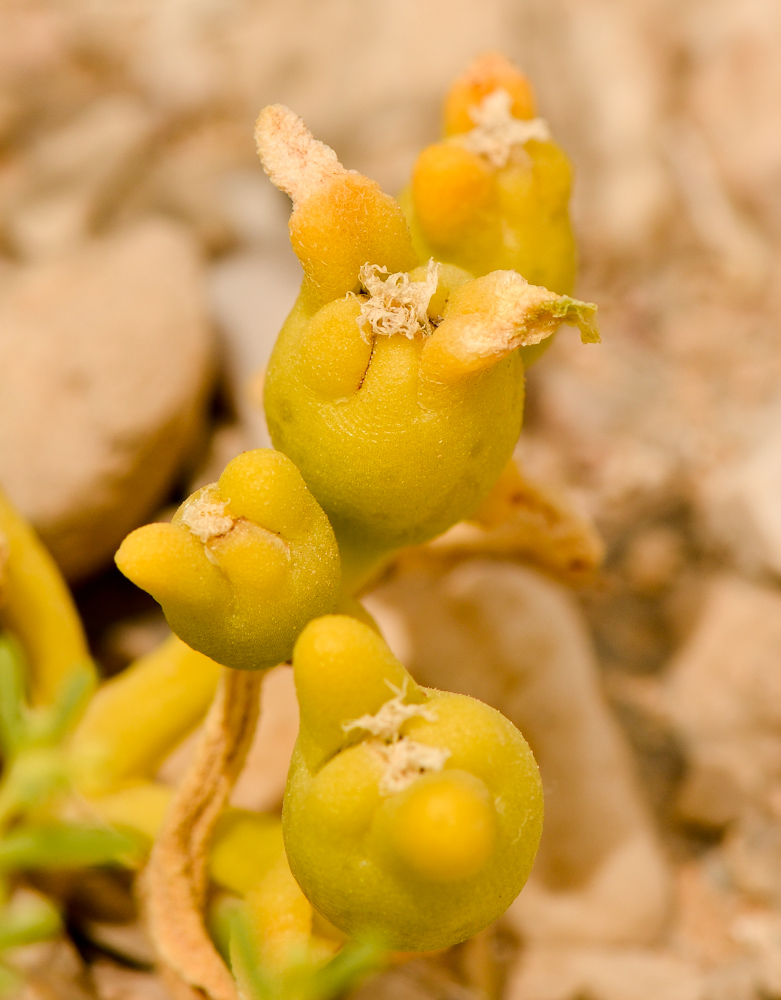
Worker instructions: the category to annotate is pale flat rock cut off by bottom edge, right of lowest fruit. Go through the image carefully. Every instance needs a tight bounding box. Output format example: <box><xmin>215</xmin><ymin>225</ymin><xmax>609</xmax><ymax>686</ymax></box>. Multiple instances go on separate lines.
<box><xmin>504</xmin><ymin>947</ymin><xmax>706</xmax><ymax>1000</ymax></box>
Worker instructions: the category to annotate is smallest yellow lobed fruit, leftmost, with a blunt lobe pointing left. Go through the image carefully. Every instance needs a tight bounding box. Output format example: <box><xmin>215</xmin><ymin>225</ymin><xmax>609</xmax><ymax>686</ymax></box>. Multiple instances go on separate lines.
<box><xmin>116</xmin><ymin>448</ymin><xmax>340</xmax><ymax>670</ymax></box>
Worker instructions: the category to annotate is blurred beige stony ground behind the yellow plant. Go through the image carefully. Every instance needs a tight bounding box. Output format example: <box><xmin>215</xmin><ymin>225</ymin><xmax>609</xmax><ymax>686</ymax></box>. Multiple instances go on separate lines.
<box><xmin>0</xmin><ymin>0</ymin><xmax>781</xmax><ymax>1000</ymax></box>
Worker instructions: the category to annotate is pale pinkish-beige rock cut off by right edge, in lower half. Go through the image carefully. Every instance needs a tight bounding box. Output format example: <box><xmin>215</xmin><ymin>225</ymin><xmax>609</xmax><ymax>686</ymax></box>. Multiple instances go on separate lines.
<box><xmin>665</xmin><ymin>576</ymin><xmax>781</xmax><ymax>825</ymax></box>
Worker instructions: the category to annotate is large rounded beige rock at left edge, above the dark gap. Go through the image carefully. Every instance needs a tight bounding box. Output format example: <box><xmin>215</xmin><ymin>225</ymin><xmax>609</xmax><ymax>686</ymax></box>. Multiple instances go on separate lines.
<box><xmin>0</xmin><ymin>220</ymin><xmax>213</xmax><ymax>578</ymax></box>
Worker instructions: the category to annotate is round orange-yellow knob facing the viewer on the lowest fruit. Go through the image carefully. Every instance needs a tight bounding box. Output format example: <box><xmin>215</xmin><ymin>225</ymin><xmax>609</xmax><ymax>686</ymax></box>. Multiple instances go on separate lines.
<box><xmin>389</xmin><ymin>771</ymin><xmax>496</xmax><ymax>882</ymax></box>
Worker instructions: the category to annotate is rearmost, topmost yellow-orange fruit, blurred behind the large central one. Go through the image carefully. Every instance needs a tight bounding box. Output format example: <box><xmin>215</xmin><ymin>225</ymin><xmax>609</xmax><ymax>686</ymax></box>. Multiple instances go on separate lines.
<box><xmin>401</xmin><ymin>53</ymin><xmax>576</xmax><ymax>365</ymax></box>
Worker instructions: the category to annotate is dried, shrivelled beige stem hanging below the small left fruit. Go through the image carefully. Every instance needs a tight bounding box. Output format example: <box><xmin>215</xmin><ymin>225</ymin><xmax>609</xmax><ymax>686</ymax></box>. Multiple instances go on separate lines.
<box><xmin>146</xmin><ymin>668</ymin><xmax>263</xmax><ymax>1000</ymax></box>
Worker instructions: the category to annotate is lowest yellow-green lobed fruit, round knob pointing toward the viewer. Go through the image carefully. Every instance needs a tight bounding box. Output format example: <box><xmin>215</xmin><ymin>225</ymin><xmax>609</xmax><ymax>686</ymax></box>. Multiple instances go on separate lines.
<box><xmin>283</xmin><ymin>615</ymin><xmax>543</xmax><ymax>951</ymax></box>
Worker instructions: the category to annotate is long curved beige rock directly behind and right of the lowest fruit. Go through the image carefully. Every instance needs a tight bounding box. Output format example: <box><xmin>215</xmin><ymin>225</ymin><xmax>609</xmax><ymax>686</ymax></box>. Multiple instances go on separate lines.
<box><xmin>364</xmin><ymin>561</ymin><xmax>670</xmax><ymax>943</ymax></box>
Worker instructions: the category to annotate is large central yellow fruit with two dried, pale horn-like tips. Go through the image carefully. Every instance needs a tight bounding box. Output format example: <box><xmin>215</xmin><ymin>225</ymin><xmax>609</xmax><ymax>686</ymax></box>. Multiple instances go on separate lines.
<box><xmin>257</xmin><ymin>106</ymin><xmax>593</xmax><ymax>590</ymax></box>
